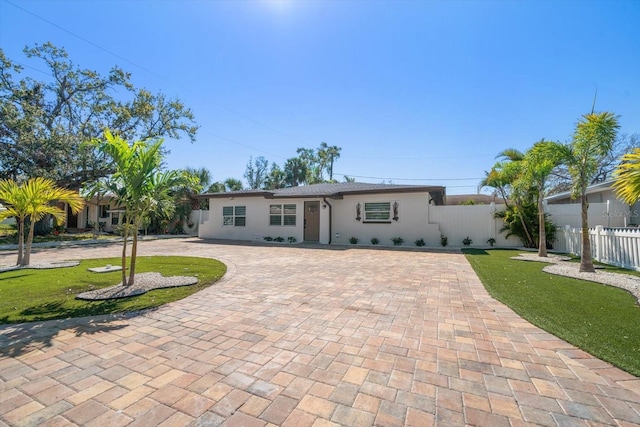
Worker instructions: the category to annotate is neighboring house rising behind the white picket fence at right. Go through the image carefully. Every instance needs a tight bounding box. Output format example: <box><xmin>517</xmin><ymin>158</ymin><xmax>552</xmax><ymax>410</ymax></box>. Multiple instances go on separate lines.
<box><xmin>544</xmin><ymin>181</ymin><xmax>640</xmax><ymax>227</ymax></box>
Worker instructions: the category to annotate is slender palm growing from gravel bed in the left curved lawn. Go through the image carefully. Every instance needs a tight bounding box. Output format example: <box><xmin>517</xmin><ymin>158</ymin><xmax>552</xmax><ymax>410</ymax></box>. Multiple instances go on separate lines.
<box><xmin>94</xmin><ymin>131</ymin><xmax>185</xmax><ymax>286</ymax></box>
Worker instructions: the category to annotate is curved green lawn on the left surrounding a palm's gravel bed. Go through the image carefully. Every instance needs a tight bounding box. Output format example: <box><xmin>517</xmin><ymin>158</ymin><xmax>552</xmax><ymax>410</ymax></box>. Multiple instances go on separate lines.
<box><xmin>0</xmin><ymin>256</ymin><xmax>227</xmax><ymax>324</ymax></box>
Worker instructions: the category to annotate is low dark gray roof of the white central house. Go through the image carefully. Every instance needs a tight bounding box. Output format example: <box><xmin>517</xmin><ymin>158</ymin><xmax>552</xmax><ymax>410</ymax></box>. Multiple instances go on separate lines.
<box><xmin>200</xmin><ymin>182</ymin><xmax>445</xmax><ymax>204</ymax></box>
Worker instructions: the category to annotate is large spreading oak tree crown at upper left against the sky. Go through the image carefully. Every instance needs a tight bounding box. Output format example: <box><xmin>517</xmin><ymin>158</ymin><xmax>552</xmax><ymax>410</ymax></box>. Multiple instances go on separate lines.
<box><xmin>0</xmin><ymin>43</ymin><xmax>198</xmax><ymax>189</ymax></box>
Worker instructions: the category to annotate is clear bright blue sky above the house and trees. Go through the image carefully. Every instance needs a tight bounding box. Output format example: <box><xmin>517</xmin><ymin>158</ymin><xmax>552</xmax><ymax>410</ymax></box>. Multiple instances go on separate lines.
<box><xmin>0</xmin><ymin>0</ymin><xmax>640</xmax><ymax>194</ymax></box>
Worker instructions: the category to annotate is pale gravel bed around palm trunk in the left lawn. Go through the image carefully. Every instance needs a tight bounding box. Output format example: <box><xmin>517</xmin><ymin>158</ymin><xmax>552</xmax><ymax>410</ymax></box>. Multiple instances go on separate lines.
<box><xmin>76</xmin><ymin>273</ymin><xmax>198</xmax><ymax>301</ymax></box>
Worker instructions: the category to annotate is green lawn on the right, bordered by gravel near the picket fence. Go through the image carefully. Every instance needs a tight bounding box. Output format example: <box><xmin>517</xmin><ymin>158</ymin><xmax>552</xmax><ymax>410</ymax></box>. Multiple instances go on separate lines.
<box><xmin>464</xmin><ymin>249</ymin><xmax>640</xmax><ymax>376</ymax></box>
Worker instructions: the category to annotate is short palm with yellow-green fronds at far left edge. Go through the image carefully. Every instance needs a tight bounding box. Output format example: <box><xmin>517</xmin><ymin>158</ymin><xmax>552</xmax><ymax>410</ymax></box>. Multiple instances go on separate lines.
<box><xmin>0</xmin><ymin>178</ymin><xmax>84</xmax><ymax>265</ymax></box>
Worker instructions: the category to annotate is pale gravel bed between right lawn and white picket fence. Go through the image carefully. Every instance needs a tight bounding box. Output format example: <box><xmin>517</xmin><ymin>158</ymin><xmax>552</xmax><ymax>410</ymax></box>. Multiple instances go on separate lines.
<box><xmin>513</xmin><ymin>253</ymin><xmax>640</xmax><ymax>303</ymax></box>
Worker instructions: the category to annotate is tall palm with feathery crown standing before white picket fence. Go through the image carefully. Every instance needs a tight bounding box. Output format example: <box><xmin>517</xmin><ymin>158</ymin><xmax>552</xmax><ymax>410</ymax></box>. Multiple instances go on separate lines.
<box><xmin>555</xmin><ymin>112</ymin><xmax>620</xmax><ymax>273</ymax></box>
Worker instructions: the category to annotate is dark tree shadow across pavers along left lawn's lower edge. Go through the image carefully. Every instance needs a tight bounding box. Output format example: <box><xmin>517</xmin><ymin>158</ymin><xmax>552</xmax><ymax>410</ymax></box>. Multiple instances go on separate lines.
<box><xmin>0</xmin><ymin>302</ymin><xmax>158</xmax><ymax>357</ymax></box>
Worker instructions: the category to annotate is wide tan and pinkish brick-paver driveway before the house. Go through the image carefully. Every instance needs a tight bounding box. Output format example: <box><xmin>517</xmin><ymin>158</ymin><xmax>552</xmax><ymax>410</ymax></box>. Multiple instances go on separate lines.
<box><xmin>0</xmin><ymin>239</ymin><xmax>640</xmax><ymax>426</ymax></box>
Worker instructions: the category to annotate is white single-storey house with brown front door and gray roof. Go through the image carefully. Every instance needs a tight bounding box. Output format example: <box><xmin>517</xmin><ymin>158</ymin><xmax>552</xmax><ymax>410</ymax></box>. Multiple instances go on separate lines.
<box><xmin>198</xmin><ymin>182</ymin><xmax>445</xmax><ymax>245</ymax></box>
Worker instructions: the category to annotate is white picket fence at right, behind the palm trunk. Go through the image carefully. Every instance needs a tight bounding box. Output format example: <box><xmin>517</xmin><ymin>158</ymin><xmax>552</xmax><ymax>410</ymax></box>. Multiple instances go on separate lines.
<box><xmin>554</xmin><ymin>225</ymin><xmax>640</xmax><ymax>271</ymax></box>
